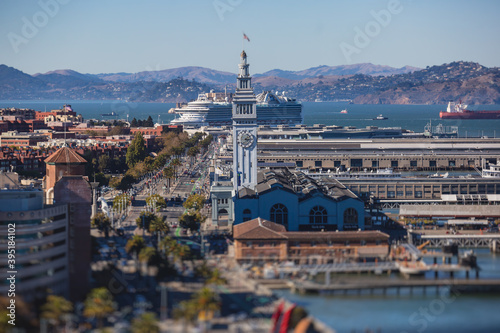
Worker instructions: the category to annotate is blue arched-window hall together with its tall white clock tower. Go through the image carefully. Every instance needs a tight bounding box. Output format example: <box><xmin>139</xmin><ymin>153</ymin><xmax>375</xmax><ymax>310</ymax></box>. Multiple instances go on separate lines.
<box><xmin>212</xmin><ymin>51</ymin><xmax>365</xmax><ymax>231</ymax></box>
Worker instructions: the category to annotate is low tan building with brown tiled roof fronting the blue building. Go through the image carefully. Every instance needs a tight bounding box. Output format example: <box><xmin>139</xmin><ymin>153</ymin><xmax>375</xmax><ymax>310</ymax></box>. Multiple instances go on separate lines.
<box><xmin>233</xmin><ymin>218</ymin><xmax>389</xmax><ymax>264</ymax></box>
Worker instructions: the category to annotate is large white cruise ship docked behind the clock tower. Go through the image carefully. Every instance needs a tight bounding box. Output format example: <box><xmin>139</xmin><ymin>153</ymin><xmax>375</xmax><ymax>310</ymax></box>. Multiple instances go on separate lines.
<box><xmin>171</xmin><ymin>91</ymin><xmax>302</xmax><ymax>127</ymax></box>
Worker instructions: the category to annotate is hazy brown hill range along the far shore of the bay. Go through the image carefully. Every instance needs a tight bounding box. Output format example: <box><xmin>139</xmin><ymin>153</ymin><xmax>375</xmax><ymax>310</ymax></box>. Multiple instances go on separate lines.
<box><xmin>0</xmin><ymin>61</ymin><xmax>500</xmax><ymax>104</ymax></box>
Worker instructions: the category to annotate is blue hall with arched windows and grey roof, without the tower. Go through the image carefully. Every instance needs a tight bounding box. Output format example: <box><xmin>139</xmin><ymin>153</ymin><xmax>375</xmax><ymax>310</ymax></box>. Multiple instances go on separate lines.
<box><xmin>234</xmin><ymin>170</ymin><xmax>365</xmax><ymax>231</ymax></box>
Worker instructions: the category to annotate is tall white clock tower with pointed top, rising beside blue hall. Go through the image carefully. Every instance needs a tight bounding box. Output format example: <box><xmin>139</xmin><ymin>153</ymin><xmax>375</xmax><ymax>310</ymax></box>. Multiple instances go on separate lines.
<box><xmin>233</xmin><ymin>51</ymin><xmax>257</xmax><ymax>191</ymax></box>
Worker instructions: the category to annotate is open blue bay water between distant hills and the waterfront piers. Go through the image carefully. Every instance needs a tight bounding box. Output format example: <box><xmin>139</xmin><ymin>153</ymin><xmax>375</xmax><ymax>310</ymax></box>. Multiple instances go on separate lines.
<box><xmin>0</xmin><ymin>100</ymin><xmax>500</xmax><ymax>137</ymax></box>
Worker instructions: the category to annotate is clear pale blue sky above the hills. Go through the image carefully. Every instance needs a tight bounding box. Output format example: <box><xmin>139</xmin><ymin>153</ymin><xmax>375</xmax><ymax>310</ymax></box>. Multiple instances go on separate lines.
<box><xmin>0</xmin><ymin>0</ymin><xmax>500</xmax><ymax>74</ymax></box>
